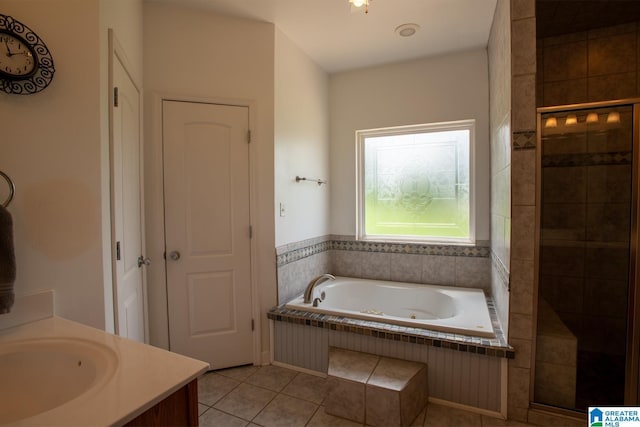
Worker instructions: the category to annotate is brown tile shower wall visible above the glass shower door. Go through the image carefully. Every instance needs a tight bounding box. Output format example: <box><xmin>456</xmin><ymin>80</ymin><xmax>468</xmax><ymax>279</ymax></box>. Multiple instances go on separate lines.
<box><xmin>536</xmin><ymin>22</ymin><xmax>640</xmax><ymax>107</ymax></box>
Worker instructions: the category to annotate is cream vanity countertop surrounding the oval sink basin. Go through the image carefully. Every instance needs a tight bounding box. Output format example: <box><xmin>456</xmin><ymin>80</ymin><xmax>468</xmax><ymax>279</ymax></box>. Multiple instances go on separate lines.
<box><xmin>0</xmin><ymin>317</ymin><xmax>209</xmax><ymax>426</ymax></box>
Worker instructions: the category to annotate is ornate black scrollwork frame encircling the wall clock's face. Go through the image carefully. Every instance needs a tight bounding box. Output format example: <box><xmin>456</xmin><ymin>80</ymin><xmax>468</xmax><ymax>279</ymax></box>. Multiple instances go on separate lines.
<box><xmin>0</xmin><ymin>14</ymin><xmax>55</xmax><ymax>95</ymax></box>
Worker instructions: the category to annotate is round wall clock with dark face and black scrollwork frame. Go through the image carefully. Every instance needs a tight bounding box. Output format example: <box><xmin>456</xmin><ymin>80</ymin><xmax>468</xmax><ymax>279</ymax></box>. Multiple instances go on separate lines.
<box><xmin>0</xmin><ymin>14</ymin><xmax>55</xmax><ymax>95</ymax></box>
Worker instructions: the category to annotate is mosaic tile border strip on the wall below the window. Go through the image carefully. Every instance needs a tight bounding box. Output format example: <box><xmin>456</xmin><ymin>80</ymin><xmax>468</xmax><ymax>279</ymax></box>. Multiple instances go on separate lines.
<box><xmin>276</xmin><ymin>239</ymin><xmax>491</xmax><ymax>267</ymax></box>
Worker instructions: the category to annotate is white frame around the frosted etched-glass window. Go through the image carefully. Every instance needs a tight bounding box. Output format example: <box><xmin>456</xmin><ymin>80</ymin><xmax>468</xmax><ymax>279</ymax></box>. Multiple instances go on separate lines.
<box><xmin>356</xmin><ymin>119</ymin><xmax>476</xmax><ymax>245</ymax></box>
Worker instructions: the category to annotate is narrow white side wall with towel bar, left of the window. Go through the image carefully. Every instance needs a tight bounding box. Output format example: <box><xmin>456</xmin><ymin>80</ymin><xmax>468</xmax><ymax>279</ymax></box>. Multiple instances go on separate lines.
<box><xmin>275</xmin><ymin>29</ymin><xmax>332</xmax><ymax>247</ymax></box>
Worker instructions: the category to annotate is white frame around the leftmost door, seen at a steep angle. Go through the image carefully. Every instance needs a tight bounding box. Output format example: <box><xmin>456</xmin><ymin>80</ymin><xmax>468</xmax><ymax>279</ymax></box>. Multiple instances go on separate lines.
<box><xmin>108</xmin><ymin>28</ymin><xmax>149</xmax><ymax>343</ymax></box>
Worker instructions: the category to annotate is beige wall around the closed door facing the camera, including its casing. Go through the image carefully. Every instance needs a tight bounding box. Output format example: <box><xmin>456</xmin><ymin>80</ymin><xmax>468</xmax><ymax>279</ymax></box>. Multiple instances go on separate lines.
<box><xmin>144</xmin><ymin>3</ymin><xmax>276</xmax><ymax>360</ymax></box>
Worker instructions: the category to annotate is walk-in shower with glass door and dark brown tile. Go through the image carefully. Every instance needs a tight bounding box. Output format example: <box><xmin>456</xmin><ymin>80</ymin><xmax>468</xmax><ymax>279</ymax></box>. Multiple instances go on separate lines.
<box><xmin>533</xmin><ymin>99</ymin><xmax>640</xmax><ymax>412</ymax></box>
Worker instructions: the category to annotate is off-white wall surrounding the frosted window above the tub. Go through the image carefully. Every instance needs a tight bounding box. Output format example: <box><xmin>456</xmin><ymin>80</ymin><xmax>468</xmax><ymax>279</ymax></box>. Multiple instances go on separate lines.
<box><xmin>329</xmin><ymin>49</ymin><xmax>490</xmax><ymax>241</ymax></box>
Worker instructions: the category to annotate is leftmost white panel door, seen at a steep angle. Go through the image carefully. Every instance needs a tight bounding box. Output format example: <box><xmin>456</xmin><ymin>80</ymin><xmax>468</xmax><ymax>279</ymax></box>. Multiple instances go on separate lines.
<box><xmin>111</xmin><ymin>55</ymin><xmax>146</xmax><ymax>342</ymax></box>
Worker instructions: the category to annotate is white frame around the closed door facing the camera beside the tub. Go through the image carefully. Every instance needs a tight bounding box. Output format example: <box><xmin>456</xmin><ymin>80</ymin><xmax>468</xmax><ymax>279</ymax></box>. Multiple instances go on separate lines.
<box><xmin>145</xmin><ymin>92</ymin><xmax>263</xmax><ymax>365</ymax></box>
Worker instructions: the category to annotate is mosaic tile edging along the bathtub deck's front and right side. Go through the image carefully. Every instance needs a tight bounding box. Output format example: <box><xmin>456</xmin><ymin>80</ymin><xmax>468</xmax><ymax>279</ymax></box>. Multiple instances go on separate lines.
<box><xmin>267</xmin><ymin>297</ymin><xmax>515</xmax><ymax>359</ymax></box>
